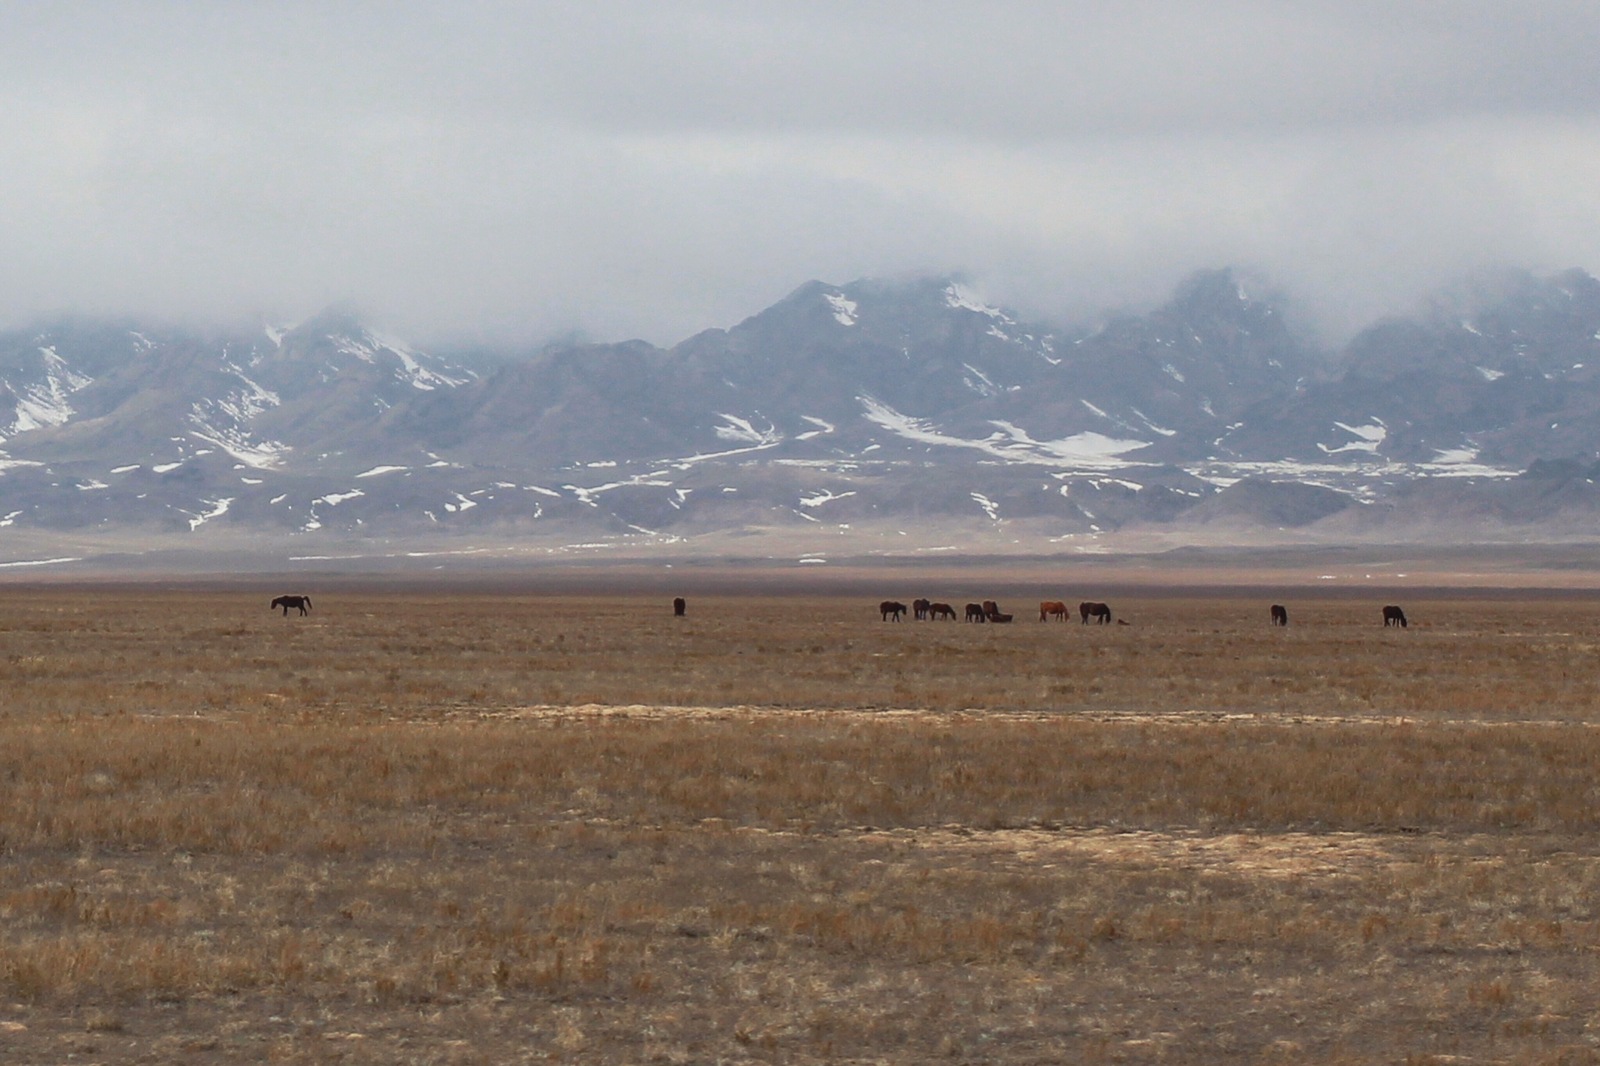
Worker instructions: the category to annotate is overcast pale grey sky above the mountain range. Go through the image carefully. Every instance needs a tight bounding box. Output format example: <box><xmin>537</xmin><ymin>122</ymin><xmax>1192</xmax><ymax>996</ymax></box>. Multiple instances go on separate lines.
<box><xmin>0</xmin><ymin>0</ymin><xmax>1600</xmax><ymax>344</ymax></box>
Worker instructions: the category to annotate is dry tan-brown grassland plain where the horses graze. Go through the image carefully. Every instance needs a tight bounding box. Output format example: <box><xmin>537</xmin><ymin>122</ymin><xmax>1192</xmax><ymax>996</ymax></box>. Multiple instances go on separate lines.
<box><xmin>0</xmin><ymin>579</ymin><xmax>1600</xmax><ymax>1064</ymax></box>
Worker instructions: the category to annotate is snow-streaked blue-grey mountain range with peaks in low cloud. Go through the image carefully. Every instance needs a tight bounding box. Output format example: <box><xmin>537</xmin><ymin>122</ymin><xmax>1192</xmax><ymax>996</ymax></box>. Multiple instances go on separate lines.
<box><xmin>0</xmin><ymin>271</ymin><xmax>1600</xmax><ymax>549</ymax></box>
